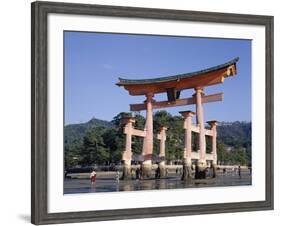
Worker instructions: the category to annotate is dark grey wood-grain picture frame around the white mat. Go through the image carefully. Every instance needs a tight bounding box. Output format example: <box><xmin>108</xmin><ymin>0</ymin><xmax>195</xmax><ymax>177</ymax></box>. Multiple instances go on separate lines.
<box><xmin>31</xmin><ymin>2</ymin><xmax>274</xmax><ymax>224</ymax></box>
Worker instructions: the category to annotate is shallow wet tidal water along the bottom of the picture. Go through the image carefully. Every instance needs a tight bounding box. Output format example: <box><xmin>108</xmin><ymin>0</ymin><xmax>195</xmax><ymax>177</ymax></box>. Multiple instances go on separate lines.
<box><xmin>64</xmin><ymin>172</ymin><xmax>252</xmax><ymax>194</ymax></box>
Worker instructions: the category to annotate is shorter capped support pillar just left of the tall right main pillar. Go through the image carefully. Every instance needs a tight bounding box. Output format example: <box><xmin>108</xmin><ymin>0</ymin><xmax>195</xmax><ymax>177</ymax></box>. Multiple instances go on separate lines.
<box><xmin>180</xmin><ymin>111</ymin><xmax>195</xmax><ymax>180</ymax></box>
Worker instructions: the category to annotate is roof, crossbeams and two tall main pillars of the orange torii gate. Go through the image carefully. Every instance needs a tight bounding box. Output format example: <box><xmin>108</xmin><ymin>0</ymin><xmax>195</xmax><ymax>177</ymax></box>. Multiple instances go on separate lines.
<box><xmin>116</xmin><ymin>58</ymin><xmax>239</xmax><ymax>178</ymax></box>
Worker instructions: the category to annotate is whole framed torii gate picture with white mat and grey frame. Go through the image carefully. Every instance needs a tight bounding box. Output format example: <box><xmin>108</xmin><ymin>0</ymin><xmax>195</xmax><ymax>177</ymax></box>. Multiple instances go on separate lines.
<box><xmin>31</xmin><ymin>2</ymin><xmax>273</xmax><ymax>224</ymax></box>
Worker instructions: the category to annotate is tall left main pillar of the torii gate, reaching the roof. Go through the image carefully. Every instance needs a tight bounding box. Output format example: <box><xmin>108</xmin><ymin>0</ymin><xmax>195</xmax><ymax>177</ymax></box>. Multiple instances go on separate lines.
<box><xmin>142</xmin><ymin>93</ymin><xmax>154</xmax><ymax>178</ymax></box>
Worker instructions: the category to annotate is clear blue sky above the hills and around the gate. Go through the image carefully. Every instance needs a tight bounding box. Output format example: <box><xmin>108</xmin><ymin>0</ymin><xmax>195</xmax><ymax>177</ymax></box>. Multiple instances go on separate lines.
<box><xmin>64</xmin><ymin>32</ymin><xmax>252</xmax><ymax>124</ymax></box>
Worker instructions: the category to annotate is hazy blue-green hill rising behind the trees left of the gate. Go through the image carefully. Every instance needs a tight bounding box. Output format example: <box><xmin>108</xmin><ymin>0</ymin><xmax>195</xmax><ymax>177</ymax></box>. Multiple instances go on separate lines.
<box><xmin>64</xmin><ymin>117</ymin><xmax>114</xmax><ymax>144</ymax></box>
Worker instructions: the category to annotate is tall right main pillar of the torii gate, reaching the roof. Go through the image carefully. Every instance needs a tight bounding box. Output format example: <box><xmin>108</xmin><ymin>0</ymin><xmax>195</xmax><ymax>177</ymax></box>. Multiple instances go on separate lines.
<box><xmin>195</xmin><ymin>87</ymin><xmax>206</xmax><ymax>179</ymax></box>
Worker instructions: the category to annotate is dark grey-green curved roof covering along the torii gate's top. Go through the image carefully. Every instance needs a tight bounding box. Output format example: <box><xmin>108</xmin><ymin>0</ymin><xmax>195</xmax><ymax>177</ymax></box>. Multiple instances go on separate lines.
<box><xmin>116</xmin><ymin>57</ymin><xmax>239</xmax><ymax>86</ymax></box>
